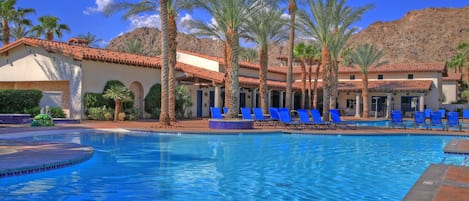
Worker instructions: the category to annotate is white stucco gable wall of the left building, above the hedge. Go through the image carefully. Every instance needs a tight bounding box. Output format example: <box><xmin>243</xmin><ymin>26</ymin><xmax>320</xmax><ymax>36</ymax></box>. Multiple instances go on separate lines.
<box><xmin>0</xmin><ymin>46</ymin><xmax>82</xmax><ymax>118</ymax></box>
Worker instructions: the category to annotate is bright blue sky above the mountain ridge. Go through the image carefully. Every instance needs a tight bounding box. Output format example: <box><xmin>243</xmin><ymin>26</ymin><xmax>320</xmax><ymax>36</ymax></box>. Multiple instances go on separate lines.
<box><xmin>12</xmin><ymin>0</ymin><xmax>469</xmax><ymax>46</ymax></box>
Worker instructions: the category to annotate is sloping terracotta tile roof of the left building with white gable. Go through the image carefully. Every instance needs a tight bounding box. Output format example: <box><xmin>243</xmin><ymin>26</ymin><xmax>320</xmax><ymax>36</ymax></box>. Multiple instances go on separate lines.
<box><xmin>0</xmin><ymin>38</ymin><xmax>160</xmax><ymax>68</ymax></box>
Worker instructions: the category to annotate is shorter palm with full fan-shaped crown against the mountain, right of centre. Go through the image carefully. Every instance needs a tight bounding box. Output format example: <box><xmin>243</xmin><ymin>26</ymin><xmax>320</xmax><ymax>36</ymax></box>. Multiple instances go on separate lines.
<box><xmin>344</xmin><ymin>44</ymin><xmax>384</xmax><ymax>118</ymax></box>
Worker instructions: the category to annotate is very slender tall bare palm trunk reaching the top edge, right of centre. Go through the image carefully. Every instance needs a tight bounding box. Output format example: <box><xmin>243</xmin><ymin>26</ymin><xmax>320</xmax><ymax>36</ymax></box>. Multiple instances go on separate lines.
<box><xmin>285</xmin><ymin>0</ymin><xmax>297</xmax><ymax>109</ymax></box>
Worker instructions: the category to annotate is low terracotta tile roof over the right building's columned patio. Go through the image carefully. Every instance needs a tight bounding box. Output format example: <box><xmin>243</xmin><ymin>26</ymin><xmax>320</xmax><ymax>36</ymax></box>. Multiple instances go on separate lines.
<box><xmin>294</xmin><ymin>80</ymin><xmax>433</xmax><ymax>92</ymax></box>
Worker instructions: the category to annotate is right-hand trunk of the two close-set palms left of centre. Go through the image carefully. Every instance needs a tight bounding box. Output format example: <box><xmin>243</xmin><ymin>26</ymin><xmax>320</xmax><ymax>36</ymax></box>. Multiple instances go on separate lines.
<box><xmin>168</xmin><ymin>10</ymin><xmax>177</xmax><ymax>122</ymax></box>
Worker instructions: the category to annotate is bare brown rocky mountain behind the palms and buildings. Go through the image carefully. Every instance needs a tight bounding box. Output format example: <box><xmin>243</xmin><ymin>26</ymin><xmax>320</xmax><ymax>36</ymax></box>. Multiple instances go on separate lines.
<box><xmin>107</xmin><ymin>6</ymin><xmax>469</xmax><ymax>66</ymax></box>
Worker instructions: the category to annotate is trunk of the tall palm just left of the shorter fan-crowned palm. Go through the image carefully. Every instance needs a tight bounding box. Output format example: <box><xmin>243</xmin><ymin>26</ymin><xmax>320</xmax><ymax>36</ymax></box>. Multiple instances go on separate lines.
<box><xmin>321</xmin><ymin>46</ymin><xmax>331</xmax><ymax>121</ymax></box>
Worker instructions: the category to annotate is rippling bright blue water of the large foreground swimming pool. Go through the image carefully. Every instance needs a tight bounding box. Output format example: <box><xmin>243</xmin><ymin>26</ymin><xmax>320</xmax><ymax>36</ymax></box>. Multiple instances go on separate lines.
<box><xmin>0</xmin><ymin>133</ymin><xmax>462</xmax><ymax>201</ymax></box>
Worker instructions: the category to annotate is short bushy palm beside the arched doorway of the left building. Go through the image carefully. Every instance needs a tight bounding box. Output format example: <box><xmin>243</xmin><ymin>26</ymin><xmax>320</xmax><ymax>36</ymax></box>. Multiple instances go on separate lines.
<box><xmin>103</xmin><ymin>85</ymin><xmax>132</xmax><ymax>121</ymax></box>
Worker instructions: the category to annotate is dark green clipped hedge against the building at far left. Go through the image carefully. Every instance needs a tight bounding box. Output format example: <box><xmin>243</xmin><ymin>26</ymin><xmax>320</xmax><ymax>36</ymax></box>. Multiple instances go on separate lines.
<box><xmin>0</xmin><ymin>89</ymin><xmax>42</xmax><ymax>114</ymax></box>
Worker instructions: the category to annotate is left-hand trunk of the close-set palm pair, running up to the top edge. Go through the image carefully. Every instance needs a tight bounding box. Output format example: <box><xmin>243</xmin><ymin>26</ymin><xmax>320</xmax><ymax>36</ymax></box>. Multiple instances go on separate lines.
<box><xmin>160</xmin><ymin>0</ymin><xmax>170</xmax><ymax>126</ymax></box>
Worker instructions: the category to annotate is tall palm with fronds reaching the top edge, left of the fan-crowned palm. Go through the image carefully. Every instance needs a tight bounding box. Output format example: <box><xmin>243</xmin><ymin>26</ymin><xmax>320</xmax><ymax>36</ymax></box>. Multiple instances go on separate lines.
<box><xmin>300</xmin><ymin>0</ymin><xmax>371</xmax><ymax>119</ymax></box>
